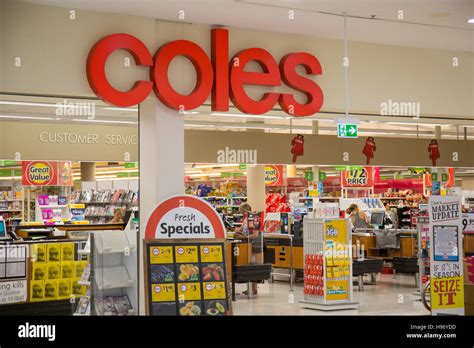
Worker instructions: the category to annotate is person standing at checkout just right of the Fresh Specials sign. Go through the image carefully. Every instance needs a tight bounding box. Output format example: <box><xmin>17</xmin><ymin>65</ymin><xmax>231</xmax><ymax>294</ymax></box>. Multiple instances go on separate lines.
<box><xmin>235</xmin><ymin>203</ymin><xmax>263</xmax><ymax>295</ymax></box>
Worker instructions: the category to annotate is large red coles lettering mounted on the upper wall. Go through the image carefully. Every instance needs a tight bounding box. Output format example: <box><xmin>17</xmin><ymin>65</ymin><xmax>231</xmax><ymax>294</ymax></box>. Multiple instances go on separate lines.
<box><xmin>87</xmin><ymin>29</ymin><xmax>323</xmax><ymax>116</ymax></box>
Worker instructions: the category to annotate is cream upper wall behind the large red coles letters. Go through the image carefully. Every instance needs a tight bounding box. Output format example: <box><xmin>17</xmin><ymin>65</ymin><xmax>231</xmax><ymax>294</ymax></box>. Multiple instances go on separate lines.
<box><xmin>0</xmin><ymin>1</ymin><xmax>474</xmax><ymax>116</ymax></box>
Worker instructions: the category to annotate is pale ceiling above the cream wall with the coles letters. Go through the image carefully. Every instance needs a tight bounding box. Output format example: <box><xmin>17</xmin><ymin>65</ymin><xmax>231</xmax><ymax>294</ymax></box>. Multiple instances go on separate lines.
<box><xmin>25</xmin><ymin>0</ymin><xmax>474</xmax><ymax>52</ymax></box>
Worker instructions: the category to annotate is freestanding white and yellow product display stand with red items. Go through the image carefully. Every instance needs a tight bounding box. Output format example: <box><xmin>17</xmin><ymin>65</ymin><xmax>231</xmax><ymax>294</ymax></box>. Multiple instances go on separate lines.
<box><xmin>300</xmin><ymin>218</ymin><xmax>359</xmax><ymax>311</ymax></box>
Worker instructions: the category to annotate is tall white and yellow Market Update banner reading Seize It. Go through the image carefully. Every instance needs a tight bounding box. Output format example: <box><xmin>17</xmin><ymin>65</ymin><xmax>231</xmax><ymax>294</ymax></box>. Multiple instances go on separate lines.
<box><xmin>429</xmin><ymin>196</ymin><xmax>464</xmax><ymax>315</ymax></box>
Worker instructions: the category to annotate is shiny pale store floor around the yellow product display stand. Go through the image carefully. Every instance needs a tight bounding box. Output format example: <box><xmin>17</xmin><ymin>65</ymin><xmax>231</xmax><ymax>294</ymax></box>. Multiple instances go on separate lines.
<box><xmin>233</xmin><ymin>274</ymin><xmax>429</xmax><ymax>315</ymax></box>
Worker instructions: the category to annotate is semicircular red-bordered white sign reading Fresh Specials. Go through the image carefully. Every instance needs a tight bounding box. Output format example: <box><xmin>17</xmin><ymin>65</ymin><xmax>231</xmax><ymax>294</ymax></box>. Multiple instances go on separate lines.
<box><xmin>145</xmin><ymin>195</ymin><xmax>226</xmax><ymax>240</ymax></box>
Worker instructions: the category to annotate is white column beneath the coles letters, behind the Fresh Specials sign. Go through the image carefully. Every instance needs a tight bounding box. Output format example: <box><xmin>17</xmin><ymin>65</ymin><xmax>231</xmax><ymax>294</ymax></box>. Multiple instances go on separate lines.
<box><xmin>139</xmin><ymin>95</ymin><xmax>184</xmax><ymax>314</ymax></box>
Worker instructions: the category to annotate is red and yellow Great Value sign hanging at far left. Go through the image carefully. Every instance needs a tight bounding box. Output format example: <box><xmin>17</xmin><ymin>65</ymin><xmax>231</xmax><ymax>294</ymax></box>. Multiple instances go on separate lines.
<box><xmin>21</xmin><ymin>161</ymin><xmax>74</xmax><ymax>186</ymax></box>
